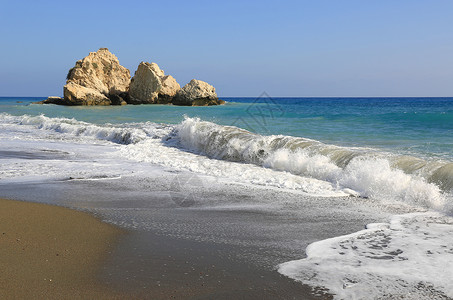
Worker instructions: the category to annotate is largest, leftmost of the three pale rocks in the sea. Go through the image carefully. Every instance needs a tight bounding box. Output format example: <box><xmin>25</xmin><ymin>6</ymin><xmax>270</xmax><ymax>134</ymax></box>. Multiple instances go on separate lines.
<box><xmin>61</xmin><ymin>48</ymin><xmax>130</xmax><ymax>105</ymax></box>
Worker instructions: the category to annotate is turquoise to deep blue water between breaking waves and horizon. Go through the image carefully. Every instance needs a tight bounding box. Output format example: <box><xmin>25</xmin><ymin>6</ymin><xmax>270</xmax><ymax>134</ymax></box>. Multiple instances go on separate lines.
<box><xmin>0</xmin><ymin>95</ymin><xmax>453</xmax><ymax>160</ymax></box>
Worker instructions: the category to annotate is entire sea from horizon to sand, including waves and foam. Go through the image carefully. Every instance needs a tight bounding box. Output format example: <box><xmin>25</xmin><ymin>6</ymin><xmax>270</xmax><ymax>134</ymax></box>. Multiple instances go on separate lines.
<box><xmin>0</xmin><ymin>93</ymin><xmax>453</xmax><ymax>299</ymax></box>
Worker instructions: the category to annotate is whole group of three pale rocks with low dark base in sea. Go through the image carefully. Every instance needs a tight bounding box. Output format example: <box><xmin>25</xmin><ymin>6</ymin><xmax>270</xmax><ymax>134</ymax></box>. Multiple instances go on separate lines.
<box><xmin>38</xmin><ymin>48</ymin><xmax>225</xmax><ymax>106</ymax></box>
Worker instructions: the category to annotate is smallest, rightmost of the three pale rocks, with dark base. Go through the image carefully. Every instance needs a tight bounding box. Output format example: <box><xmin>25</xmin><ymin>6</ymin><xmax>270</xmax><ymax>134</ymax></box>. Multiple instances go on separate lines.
<box><xmin>173</xmin><ymin>79</ymin><xmax>225</xmax><ymax>106</ymax></box>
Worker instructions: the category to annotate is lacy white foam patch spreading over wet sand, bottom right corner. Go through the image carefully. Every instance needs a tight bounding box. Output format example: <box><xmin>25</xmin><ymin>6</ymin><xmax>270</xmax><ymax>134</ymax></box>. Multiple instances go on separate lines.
<box><xmin>278</xmin><ymin>213</ymin><xmax>453</xmax><ymax>299</ymax></box>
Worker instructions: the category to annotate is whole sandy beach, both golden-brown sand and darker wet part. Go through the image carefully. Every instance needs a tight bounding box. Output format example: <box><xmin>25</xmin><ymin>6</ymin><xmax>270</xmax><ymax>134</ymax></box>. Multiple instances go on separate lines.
<box><xmin>0</xmin><ymin>200</ymin><xmax>329</xmax><ymax>299</ymax></box>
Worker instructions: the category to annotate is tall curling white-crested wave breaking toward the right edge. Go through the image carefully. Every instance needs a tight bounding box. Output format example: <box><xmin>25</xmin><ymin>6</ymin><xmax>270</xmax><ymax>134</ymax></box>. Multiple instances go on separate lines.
<box><xmin>176</xmin><ymin>118</ymin><xmax>453</xmax><ymax>210</ymax></box>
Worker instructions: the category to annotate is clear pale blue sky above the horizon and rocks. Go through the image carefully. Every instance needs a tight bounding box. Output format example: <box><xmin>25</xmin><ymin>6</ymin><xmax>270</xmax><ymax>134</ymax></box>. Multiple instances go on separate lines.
<box><xmin>0</xmin><ymin>0</ymin><xmax>453</xmax><ymax>97</ymax></box>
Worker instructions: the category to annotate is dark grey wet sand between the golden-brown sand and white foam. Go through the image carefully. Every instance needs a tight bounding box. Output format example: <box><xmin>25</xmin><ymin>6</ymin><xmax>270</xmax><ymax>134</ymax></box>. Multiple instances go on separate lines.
<box><xmin>103</xmin><ymin>231</ymin><xmax>331</xmax><ymax>299</ymax></box>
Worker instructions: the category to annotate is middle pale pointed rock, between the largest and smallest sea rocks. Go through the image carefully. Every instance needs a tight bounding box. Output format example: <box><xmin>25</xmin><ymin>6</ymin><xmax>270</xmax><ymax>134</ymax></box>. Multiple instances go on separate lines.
<box><xmin>129</xmin><ymin>62</ymin><xmax>181</xmax><ymax>104</ymax></box>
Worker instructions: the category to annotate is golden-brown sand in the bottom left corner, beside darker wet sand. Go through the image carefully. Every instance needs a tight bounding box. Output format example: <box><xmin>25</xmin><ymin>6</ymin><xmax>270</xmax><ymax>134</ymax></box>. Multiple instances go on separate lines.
<box><xmin>0</xmin><ymin>199</ymin><xmax>124</xmax><ymax>299</ymax></box>
